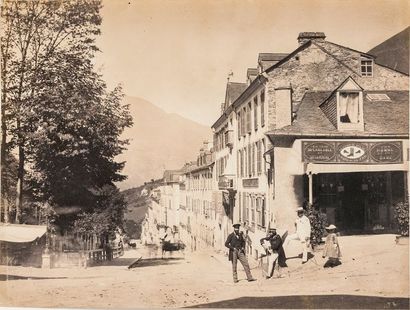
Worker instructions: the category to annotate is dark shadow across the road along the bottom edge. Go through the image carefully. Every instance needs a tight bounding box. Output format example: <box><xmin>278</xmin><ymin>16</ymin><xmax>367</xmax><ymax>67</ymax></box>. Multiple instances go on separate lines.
<box><xmin>189</xmin><ymin>295</ymin><xmax>409</xmax><ymax>309</ymax></box>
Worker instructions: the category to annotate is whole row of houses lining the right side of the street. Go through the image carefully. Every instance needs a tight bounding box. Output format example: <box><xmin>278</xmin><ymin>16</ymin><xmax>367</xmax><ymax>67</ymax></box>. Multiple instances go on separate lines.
<box><xmin>143</xmin><ymin>29</ymin><xmax>409</xmax><ymax>257</ymax></box>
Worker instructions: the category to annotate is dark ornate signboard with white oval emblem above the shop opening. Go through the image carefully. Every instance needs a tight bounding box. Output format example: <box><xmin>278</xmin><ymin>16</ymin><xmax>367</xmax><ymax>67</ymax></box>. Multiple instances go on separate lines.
<box><xmin>302</xmin><ymin>141</ymin><xmax>403</xmax><ymax>164</ymax></box>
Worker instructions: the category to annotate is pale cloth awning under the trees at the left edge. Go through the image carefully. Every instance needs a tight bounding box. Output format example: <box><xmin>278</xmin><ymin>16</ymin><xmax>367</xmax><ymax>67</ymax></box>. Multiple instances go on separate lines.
<box><xmin>0</xmin><ymin>224</ymin><xmax>47</xmax><ymax>242</ymax></box>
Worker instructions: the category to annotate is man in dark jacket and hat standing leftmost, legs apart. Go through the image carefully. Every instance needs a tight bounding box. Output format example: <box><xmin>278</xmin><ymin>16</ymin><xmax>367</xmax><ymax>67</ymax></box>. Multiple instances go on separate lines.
<box><xmin>225</xmin><ymin>224</ymin><xmax>256</xmax><ymax>283</ymax></box>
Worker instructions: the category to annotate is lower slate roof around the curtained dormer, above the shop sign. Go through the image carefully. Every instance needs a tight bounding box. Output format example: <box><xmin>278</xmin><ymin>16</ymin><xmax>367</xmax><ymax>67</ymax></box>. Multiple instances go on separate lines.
<box><xmin>267</xmin><ymin>91</ymin><xmax>409</xmax><ymax>137</ymax></box>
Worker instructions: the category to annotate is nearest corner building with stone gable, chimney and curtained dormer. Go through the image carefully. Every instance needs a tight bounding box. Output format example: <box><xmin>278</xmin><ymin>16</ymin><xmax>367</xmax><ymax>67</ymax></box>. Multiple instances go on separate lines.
<box><xmin>213</xmin><ymin>32</ymin><xmax>409</xmax><ymax>257</ymax></box>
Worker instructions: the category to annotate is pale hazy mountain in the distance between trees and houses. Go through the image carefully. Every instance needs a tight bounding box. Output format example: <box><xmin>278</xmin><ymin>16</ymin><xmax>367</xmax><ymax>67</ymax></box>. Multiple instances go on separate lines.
<box><xmin>118</xmin><ymin>96</ymin><xmax>211</xmax><ymax>189</ymax></box>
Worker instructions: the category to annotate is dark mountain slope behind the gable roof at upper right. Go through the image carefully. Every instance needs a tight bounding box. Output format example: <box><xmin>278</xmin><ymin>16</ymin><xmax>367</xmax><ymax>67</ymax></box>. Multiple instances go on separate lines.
<box><xmin>368</xmin><ymin>27</ymin><xmax>410</xmax><ymax>74</ymax></box>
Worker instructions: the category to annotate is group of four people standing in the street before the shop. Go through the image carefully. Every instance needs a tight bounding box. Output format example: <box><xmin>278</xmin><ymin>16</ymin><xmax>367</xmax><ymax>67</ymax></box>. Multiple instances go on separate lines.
<box><xmin>225</xmin><ymin>208</ymin><xmax>341</xmax><ymax>283</ymax></box>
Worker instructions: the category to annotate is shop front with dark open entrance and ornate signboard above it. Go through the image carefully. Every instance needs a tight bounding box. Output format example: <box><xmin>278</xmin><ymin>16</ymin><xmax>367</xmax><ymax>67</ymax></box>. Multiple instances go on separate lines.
<box><xmin>302</xmin><ymin>140</ymin><xmax>408</xmax><ymax>233</ymax></box>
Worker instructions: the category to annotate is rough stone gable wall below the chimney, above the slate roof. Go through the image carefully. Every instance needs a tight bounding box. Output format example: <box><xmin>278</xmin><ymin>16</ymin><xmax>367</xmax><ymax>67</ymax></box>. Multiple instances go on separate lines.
<box><xmin>266</xmin><ymin>42</ymin><xmax>409</xmax><ymax>130</ymax></box>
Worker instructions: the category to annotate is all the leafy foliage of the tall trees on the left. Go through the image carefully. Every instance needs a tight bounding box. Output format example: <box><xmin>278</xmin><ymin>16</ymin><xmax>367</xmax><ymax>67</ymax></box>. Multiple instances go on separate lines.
<box><xmin>1</xmin><ymin>0</ymin><xmax>132</xmax><ymax>235</ymax></box>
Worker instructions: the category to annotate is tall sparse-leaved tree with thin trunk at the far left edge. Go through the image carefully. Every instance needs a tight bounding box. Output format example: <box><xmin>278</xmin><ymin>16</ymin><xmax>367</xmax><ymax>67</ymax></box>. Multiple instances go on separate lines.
<box><xmin>1</xmin><ymin>0</ymin><xmax>105</xmax><ymax>222</ymax></box>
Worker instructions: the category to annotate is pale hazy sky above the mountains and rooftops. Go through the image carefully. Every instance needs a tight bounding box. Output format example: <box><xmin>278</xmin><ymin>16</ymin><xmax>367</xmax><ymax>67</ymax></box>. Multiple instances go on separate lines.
<box><xmin>97</xmin><ymin>0</ymin><xmax>410</xmax><ymax>125</ymax></box>
